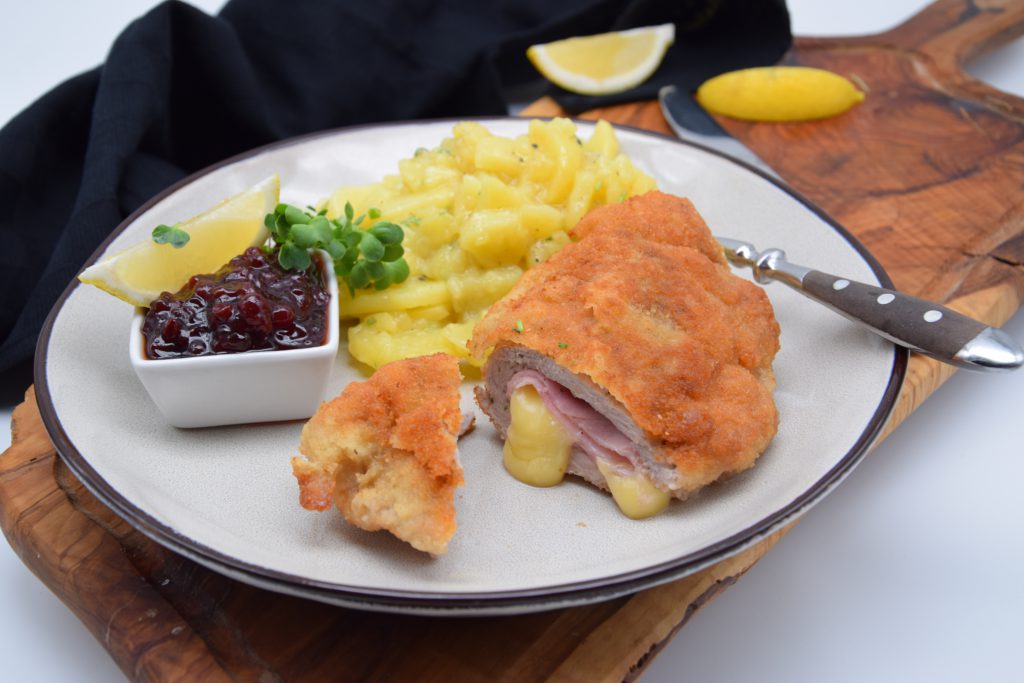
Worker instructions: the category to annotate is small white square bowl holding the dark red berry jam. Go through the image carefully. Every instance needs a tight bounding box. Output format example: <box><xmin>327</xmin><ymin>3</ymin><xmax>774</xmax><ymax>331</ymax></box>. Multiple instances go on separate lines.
<box><xmin>128</xmin><ymin>251</ymin><xmax>341</xmax><ymax>427</ymax></box>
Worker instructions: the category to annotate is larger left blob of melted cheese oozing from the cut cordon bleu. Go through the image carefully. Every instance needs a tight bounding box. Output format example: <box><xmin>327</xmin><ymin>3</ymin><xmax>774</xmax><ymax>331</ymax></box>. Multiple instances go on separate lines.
<box><xmin>505</xmin><ymin>384</ymin><xmax>572</xmax><ymax>486</ymax></box>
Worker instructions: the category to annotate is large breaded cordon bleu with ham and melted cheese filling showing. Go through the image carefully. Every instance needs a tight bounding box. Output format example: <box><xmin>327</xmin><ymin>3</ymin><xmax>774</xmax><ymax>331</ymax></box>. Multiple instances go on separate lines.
<box><xmin>469</xmin><ymin>191</ymin><xmax>779</xmax><ymax>518</ymax></box>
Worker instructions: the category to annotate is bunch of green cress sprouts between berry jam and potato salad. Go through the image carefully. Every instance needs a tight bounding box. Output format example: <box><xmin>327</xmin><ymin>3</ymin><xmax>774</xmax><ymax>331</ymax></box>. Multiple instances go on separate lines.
<box><xmin>263</xmin><ymin>198</ymin><xmax>409</xmax><ymax>295</ymax></box>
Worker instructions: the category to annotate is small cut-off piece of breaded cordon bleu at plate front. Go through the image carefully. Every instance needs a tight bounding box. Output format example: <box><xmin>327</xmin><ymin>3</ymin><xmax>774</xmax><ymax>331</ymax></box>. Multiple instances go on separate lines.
<box><xmin>292</xmin><ymin>353</ymin><xmax>463</xmax><ymax>555</ymax></box>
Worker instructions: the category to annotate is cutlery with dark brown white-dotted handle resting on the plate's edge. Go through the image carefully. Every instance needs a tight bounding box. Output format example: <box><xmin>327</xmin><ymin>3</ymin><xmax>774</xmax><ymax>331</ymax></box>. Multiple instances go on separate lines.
<box><xmin>717</xmin><ymin>238</ymin><xmax>1024</xmax><ymax>371</ymax></box>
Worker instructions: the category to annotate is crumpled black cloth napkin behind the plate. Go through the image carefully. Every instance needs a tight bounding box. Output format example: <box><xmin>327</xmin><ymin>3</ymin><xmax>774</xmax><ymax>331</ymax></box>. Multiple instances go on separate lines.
<box><xmin>0</xmin><ymin>0</ymin><xmax>791</xmax><ymax>383</ymax></box>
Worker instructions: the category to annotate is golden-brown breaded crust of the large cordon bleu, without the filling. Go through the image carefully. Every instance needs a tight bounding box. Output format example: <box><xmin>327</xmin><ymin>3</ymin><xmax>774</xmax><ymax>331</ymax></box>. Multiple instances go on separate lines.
<box><xmin>470</xmin><ymin>193</ymin><xmax>778</xmax><ymax>494</ymax></box>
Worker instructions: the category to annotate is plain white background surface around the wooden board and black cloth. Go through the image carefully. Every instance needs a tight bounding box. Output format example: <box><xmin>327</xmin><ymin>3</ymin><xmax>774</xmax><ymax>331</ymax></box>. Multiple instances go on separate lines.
<box><xmin>0</xmin><ymin>0</ymin><xmax>1024</xmax><ymax>683</ymax></box>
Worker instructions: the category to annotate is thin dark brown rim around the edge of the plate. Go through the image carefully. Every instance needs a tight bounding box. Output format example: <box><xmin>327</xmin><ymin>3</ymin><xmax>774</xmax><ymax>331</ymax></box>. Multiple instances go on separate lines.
<box><xmin>34</xmin><ymin>117</ymin><xmax>909</xmax><ymax>615</ymax></box>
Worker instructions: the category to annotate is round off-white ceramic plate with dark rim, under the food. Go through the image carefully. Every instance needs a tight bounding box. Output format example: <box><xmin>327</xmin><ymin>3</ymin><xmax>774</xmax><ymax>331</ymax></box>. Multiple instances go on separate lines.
<box><xmin>36</xmin><ymin>119</ymin><xmax>906</xmax><ymax>613</ymax></box>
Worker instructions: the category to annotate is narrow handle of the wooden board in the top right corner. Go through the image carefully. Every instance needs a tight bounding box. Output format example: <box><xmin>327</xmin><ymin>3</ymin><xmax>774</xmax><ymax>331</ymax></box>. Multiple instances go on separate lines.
<box><xmin>878</xmin><ymin>0</ymin><xmax>1024</xmax><ymax>68</ymax></box>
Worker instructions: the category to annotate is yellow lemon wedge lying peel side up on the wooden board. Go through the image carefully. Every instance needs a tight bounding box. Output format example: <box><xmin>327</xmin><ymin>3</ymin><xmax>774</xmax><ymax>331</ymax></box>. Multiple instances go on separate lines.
<box><xmin>697</xmin><ymin>67</ymin><xmax>864</xmax><ymax>122</ymax></box>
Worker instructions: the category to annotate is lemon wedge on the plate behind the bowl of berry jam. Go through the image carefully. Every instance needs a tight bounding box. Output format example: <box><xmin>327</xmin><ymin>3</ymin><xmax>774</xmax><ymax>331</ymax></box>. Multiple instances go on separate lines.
<box><xmin>78</xmin><ymin>174</ymin><xmax>281</xmax><ymax>306</ymax></box>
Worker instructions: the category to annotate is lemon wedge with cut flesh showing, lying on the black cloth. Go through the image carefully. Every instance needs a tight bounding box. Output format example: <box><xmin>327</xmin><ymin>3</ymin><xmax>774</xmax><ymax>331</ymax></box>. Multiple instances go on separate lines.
<box><xmin>526</xmin><ymin>24</ymin><xmax>676</xmax><ymax>95</ymax></box>
